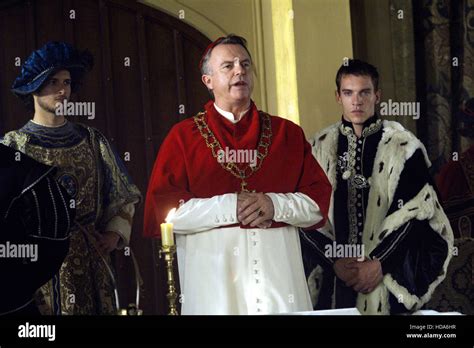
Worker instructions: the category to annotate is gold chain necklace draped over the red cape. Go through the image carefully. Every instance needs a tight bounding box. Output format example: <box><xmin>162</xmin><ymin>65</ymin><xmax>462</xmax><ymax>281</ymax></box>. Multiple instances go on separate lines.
<box><xmin>194</xmin><ymin>111</ymin><xmax>272</xmax><ymax>192</ymax></box>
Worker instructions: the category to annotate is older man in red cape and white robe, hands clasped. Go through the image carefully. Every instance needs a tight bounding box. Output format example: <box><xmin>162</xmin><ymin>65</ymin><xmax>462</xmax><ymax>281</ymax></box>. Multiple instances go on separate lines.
<box><xmin>144</xmin><ymin>34</ymin><xmax>331</xmax><ymax>314</ymax></box>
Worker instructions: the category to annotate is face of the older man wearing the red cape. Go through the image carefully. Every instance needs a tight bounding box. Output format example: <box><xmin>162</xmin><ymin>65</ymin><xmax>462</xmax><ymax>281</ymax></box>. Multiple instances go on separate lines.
<box><xmin>202</xmin><ymin>45</ymin><xmax>253</xmax><ymax>106</ymax></box>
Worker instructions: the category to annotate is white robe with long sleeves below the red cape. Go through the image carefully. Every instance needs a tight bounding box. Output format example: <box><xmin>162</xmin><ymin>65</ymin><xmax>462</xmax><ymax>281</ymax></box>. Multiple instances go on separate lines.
<box><xmin>171</xmin><ymin>193</ymin><xmax>322</xmax><ymax>315</ymax></box>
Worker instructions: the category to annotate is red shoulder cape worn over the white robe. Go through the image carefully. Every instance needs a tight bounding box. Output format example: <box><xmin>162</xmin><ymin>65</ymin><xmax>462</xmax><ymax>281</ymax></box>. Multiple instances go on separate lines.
<box><xmin>144</xmin><ymin>101</ymin><xmax>331</xmax><ymax>237</ymax></box>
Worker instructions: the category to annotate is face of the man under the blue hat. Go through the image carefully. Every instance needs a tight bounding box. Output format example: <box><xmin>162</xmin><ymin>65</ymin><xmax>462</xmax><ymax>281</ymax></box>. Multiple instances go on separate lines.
<box><xmin>33</xmin><ymin>70</ymin><xmax>71</xmax><ymax>113</ymax></box>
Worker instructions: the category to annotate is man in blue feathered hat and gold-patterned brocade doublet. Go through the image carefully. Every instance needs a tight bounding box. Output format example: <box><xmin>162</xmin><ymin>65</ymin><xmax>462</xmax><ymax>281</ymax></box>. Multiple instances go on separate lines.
<box><xmin>1</xmin><ymin>42</ymin><xmax>141</xmax><ymax>315</ymax></box>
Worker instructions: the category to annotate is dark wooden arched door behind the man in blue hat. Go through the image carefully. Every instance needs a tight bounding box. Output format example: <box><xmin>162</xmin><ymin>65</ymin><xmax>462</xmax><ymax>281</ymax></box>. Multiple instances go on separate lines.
<box><xmin>0</xmin><ymin>0</ymin><xmax>210</xmax><ymax>314</ymax></box>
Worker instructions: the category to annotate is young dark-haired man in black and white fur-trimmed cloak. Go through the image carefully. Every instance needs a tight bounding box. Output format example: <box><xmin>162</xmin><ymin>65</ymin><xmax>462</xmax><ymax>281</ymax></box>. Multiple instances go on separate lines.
<box><xmin>301</xmin><ymin>60</ymin><xmax>453</xmax><ymax>314</ymax></box>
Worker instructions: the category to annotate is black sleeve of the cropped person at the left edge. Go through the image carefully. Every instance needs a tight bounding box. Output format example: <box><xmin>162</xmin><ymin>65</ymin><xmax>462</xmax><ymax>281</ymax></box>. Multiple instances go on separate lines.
<box><xmin>0</xmin><ymin>175</ymin><xmax>75</xmax><ymax>313</ymax></box>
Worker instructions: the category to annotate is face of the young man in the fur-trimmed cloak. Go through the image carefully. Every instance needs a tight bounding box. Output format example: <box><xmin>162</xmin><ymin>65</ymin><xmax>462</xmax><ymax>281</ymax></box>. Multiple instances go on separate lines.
<box><xmin>336</xmin><ymin>75</ymin><xmax>380</xmax><ymax>125</ymax></box>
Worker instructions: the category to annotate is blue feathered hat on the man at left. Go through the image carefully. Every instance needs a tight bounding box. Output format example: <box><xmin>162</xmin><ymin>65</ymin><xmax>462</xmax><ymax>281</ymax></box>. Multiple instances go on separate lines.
<box><xmin>12</xmin><ymin>41</ymin><xmax>94</xmax><ymax>97</ymax></box>
